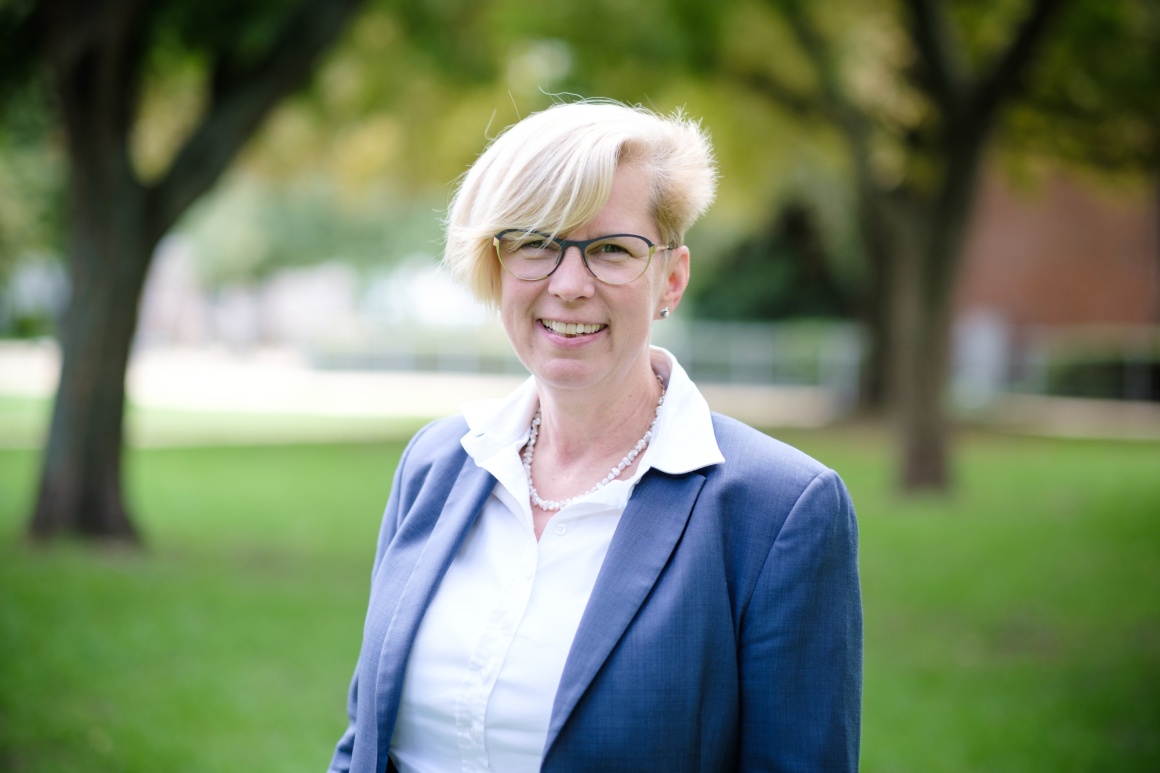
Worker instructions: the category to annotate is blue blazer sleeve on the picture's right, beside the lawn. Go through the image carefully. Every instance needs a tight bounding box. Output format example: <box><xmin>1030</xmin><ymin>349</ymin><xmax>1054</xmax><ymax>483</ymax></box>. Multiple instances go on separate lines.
<box><xmin>739</xmin><ymin>470</ymin><xmax>862</xmax><ymax>772</ymax></box>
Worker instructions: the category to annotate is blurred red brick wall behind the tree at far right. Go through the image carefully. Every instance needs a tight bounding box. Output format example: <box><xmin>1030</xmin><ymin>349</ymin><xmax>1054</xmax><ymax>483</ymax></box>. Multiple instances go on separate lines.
<box><xmin>956</xmin><ymin>168</ymin><xmax>1160</xmax><ymax>326</ymax></box>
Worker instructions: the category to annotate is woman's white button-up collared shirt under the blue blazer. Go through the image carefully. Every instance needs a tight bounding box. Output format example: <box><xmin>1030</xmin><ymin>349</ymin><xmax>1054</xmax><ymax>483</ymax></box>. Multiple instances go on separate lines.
<box><xmin>391</xmin><ymin>347</ymin><xmax>724</xmax><ymax>773</ymax></box>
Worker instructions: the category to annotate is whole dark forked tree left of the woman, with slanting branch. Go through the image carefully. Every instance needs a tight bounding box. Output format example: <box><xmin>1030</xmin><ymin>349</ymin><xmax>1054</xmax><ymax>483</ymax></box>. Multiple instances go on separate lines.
<box><xmin>0</xmin><ymin>0</ymin><xmax>362</xmax><ymax>542</ymax></box>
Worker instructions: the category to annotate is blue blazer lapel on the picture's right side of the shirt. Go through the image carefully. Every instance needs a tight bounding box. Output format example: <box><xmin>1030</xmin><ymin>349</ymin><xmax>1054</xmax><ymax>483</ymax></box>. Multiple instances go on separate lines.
<box><xmin>544</xmin><ymin>471</ymin><xmax>705</xmax><ymax>756</ymax></box>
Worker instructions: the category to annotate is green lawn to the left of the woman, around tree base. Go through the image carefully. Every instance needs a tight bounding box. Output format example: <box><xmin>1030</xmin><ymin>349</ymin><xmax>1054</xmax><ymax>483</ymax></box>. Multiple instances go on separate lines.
<box><xmin>0</xmin><ymin>442</ymin><xmax>401</xmax><ymax>773</ymax></box>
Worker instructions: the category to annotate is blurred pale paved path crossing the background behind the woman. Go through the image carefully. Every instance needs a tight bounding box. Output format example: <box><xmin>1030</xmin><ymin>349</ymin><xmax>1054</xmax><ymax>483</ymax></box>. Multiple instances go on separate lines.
<box><xmin>0</xmin><ymin>342</ymin><xmax>1160</xmax><ymax>446</ymax></box>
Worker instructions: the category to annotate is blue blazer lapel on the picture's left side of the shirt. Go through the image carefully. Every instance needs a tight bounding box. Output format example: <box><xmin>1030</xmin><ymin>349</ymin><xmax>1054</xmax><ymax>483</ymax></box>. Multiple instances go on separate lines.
<box><xmin>376</xmin><ymin>458</ymin><xmax>495</xmax><ymax>767</ymax></box>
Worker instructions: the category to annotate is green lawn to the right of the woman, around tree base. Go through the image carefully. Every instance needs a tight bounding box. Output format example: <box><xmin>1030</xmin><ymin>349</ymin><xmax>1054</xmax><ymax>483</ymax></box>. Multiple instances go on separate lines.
<box><xmin>790</xmin><ymin>433</ymin><xmax>1160</xmax><ymax>772</ymax></box>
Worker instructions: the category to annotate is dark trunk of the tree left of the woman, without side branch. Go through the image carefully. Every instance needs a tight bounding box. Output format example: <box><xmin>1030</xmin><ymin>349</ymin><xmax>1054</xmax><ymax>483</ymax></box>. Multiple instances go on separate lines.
<box><xmin>30</xmin><ymin>0</ymin><xmax>151</xmax><ymax>542</ymax></box>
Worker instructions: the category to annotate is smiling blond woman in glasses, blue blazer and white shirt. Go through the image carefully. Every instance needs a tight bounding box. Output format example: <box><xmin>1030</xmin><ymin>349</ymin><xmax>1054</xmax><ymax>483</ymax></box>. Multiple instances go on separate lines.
<box><xmin>331</xmin><ymin>102</ymin><xmax>862</xmax><ymax>773</ymax></box>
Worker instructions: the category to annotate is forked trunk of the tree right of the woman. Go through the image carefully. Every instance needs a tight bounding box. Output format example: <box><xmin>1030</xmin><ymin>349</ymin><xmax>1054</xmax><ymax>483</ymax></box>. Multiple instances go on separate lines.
<box><xmin>894</xmin><ymin>0</ymin><xmax>1065</xmax><ymax>491</ymax></box>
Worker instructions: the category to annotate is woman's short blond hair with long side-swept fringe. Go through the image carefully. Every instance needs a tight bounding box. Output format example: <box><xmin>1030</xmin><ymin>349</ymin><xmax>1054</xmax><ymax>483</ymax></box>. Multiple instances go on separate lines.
<box><xmin>443</xmin><ymin>100</ymin><xmax>717</xmax><ymax>306</ymax></box>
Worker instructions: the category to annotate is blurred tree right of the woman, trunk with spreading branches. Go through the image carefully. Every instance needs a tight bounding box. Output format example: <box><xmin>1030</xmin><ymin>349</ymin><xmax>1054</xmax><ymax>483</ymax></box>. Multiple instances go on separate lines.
<box><xmin>726</xmin><ymin>0</ymin><xmax>1065</xmax><ymax>490</ymax></box>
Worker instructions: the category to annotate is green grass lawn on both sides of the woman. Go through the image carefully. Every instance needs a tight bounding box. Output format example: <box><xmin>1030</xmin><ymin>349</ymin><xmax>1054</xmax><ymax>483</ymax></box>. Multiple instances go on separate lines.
<box><xmin>0</xmin><ymin>427</ymin><xmax>1160</xmax><ymax>773</ymax></box>
